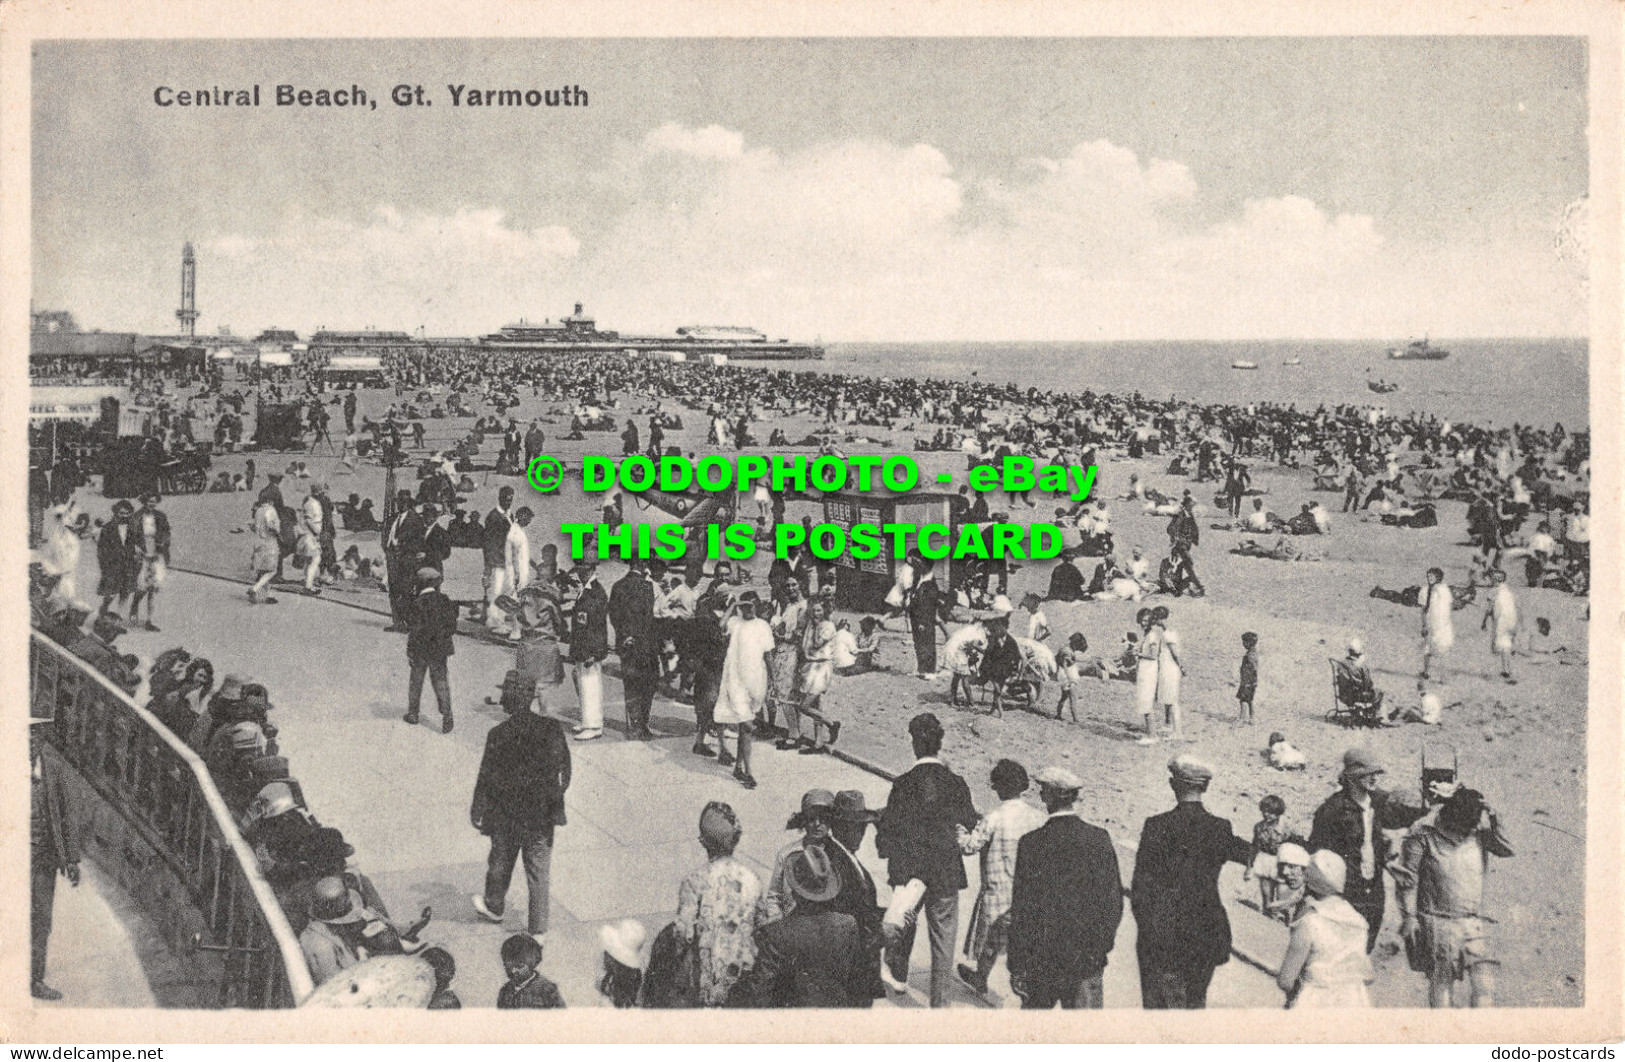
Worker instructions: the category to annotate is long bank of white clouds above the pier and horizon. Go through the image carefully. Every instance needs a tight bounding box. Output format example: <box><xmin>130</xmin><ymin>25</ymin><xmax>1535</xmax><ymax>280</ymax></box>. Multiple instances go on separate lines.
<box><xmin>181</xmin><ymin>123</ymin><xmax>1584</xmax><ymax>339</ymax></box>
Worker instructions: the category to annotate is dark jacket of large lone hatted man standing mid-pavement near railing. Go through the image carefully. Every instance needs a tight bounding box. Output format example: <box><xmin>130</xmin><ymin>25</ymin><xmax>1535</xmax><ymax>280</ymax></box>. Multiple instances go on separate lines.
<box><xmin>470</xmin><ymin>711</ymin><xmax>570</xmax><ymax>838</ymax></box>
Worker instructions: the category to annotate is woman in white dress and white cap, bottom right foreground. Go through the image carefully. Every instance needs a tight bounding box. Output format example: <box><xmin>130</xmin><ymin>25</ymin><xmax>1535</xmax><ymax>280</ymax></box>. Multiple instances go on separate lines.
<box><xmin>1276</xmin><ymin>851</ymin><xmax>1372</xmax><ymax>1008</ymax></box>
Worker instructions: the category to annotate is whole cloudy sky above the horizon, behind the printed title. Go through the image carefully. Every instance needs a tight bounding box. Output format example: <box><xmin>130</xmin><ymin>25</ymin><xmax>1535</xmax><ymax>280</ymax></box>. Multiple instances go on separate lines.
<box><xmin>33</xmin><ymin>37</ymin><xmax>1588</xmax><ymax>341</ymax></box>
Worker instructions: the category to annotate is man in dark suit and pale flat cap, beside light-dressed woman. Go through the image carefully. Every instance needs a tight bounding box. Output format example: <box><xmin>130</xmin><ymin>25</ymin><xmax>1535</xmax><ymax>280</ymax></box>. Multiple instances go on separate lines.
<box><xmin>1009</xmin><ymin>766</ymin><xmax>1123</xmax><ymax>1010</ymax></box>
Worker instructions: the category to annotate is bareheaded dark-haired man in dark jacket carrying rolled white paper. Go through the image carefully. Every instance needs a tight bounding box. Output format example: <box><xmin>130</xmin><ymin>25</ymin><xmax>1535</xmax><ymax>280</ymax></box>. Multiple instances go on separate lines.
<box><xmin>874</xmin><ymin>711</ymin><xmax>978</xmax><ymax>1007</ymax></box>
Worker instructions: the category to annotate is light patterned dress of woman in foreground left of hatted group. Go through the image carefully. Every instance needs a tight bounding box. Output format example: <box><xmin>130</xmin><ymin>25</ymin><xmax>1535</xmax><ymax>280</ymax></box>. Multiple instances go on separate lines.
<box><xmin>676</xmin><ymin>856</ymin><xmax>762</xmax><ymax>1007</ymax></box>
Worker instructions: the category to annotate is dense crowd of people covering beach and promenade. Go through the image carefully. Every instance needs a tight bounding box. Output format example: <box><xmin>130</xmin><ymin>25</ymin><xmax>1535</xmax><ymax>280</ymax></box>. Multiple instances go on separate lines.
<box><xmin>31</xmin><ymin>339</ymin><xmax>1589</xmax><ymax>1008</ymax></box>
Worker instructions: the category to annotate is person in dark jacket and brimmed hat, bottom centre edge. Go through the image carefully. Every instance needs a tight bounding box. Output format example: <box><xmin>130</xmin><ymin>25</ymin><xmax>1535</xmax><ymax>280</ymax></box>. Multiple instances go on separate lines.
<box><xmin>752</xmin><ymin>844</ymin><xmax>865</xmax><ymax>1007</ymax></box>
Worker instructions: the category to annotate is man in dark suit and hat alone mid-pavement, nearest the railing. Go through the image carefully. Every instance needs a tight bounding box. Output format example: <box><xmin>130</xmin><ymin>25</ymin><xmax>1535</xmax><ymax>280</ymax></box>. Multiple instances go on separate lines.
<box><xmin>468</xmin><ymin>671</ymin><xmax>570</xmax><ymax>943</ymax></box>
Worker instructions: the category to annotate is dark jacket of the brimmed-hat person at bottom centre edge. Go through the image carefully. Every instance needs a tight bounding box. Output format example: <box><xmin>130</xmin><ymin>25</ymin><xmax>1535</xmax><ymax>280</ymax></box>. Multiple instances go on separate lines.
<box><xmin>752</xmin><ymin>904</ymin><xmax>868</xmax><ymax>1007</ymax></box>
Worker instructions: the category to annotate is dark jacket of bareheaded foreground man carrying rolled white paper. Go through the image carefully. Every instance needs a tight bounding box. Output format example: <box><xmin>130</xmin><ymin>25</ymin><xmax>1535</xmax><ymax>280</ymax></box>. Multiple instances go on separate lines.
<box><xmin>874</xmin><ymin>763</ymin><xmax>978</xmax><ymax>891</ymax></box>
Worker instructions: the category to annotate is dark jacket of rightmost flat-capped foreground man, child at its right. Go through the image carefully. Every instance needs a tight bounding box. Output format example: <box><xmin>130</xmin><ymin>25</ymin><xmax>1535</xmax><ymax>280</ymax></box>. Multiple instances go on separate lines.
<box><xmin>1137</xmin><ymin>802</ymin><xmax>1253</xmax><ymax>968</ymax></box>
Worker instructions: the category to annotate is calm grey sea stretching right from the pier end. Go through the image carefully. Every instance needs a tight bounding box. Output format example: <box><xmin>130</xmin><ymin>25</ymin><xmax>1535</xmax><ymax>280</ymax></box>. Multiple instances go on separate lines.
<box><xmin>775</xmin><ymin>339</ymin><xmax>1589</xmax><ymax>429</ymax></box>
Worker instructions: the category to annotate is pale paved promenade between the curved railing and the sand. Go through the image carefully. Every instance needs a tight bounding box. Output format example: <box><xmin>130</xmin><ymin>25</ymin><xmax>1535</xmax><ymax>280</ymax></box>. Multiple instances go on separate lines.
<box><xmin>54</xmin><ymin>572</ymin><xmax>1284</xmax><ymax>1007</ymax></box>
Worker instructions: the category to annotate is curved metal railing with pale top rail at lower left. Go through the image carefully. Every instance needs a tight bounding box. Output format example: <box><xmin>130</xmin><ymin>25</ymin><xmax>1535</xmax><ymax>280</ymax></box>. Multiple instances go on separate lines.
<box><xmin>29</xmin><ymin>630</ymin><xmax>314</xmax><ymax>1008</ymax></box>
